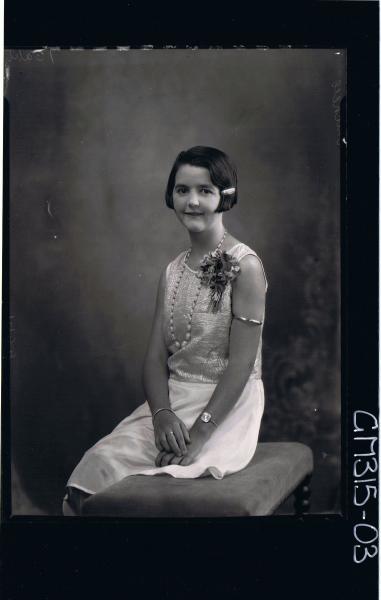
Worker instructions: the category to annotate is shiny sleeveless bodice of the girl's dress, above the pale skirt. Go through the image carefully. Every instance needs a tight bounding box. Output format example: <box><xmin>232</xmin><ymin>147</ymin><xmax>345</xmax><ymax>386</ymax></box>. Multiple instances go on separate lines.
<box><xmin>163</xmin><ymin>243</ymin><xmax>267</xmax><ymax>383</ymax></box>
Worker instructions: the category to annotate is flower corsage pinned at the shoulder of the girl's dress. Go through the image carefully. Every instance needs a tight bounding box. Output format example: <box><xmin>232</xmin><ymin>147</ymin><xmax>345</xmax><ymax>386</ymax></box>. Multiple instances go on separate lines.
<box><xmin>199</xmin><ymin>250</ymin><xmax>241</xmax><ymax>313</ymax></box>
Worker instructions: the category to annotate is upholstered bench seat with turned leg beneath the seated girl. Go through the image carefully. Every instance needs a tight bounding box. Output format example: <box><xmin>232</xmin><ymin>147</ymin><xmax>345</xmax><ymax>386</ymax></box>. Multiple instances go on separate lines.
<box><xmin>83</xmin><ymin>442</ymin><xmax>313</xmax><ymax>518</ymax></box>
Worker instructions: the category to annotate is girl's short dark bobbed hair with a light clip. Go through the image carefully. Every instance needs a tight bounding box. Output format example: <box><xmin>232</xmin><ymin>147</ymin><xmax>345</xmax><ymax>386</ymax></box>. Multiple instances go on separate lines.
<box><xmin>165</xmin><ymin>146</ymin><xmax>238</xmax><ymax>212</ymax></box>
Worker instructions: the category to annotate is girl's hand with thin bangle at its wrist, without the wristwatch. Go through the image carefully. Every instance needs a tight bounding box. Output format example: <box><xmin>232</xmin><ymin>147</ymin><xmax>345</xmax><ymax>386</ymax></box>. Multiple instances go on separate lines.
<box><xmin>153</xmin><ymin>410</ymin><xmax>190</xmax><ymax>458</ymax></box>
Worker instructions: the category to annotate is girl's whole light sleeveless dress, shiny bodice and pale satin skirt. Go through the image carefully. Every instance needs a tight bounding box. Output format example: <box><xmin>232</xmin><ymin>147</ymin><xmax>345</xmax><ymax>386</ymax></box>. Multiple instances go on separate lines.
<box><xmin>63</xmin><ymin>243</ymin><xmax>267</xmax><ymax>502</ymax></box>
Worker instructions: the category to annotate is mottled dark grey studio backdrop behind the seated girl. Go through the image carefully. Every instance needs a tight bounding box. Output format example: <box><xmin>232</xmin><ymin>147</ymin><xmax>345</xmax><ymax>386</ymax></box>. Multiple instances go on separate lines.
<box><xmin>6</xmin><ymin>49</ymin><xmax>346</xmax><ymax>515</ymax></box>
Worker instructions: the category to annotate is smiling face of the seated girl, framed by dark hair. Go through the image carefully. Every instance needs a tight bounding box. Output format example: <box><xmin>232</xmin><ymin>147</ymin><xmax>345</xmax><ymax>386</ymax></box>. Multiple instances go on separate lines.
<box><xmin>173</xmin><ymin>165</ymin><xmax>221</xmax><ymax>232</ymax></box>
